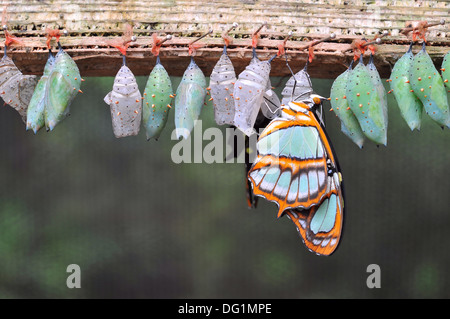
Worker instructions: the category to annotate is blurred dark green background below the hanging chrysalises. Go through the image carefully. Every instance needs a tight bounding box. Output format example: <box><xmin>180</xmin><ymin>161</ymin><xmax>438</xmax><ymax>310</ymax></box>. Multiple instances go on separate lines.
<box><xmin>0</xmin><ymin>64</ymin><xmax>450</xmax><ymax>298</ymax></box>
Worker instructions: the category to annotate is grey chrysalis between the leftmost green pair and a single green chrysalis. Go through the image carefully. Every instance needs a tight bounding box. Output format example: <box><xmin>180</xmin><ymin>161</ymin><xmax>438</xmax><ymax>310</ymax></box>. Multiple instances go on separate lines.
<box><xmin>104</xmin><ymin>56</ymin><xmax>142</xmax><ymax>138</ymax></box>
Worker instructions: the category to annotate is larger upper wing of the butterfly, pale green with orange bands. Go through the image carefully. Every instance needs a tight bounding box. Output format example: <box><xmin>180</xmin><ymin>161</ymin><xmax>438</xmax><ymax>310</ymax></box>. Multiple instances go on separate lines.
<box><xmin>248</xmin><ymin>107</ymin><xmax>331</xmax><ymax>216</ymax></box>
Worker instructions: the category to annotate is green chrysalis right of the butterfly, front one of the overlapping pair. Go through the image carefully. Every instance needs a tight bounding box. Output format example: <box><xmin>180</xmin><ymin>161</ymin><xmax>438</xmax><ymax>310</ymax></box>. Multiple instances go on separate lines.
<box><xmin>346</xmin><ymin>55</ymin><xmax>387</xmax><ymax>145</ymax></box>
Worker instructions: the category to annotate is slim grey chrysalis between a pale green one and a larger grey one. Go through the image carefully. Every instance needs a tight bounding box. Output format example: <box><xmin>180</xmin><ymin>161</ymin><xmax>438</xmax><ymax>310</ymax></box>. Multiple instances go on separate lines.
<box><xmin>209</xmin><ymin>46</ymin><xmax>236</xmax><ymax>125</ymax></box>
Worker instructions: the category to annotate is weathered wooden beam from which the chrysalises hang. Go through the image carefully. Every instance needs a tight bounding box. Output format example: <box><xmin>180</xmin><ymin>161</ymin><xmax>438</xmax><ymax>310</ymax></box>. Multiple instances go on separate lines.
<box><xmin>3</xmin><ymin>0</ymin><xmax>450</xmax><ymax>78</ymax></box>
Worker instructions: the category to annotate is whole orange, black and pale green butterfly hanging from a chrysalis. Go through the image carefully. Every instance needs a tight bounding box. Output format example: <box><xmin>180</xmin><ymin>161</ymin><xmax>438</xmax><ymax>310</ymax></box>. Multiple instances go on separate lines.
<box><xmin>248</xmin><ymin>94</ymin><xmax>344</xmax><ymax>255</ymax></box>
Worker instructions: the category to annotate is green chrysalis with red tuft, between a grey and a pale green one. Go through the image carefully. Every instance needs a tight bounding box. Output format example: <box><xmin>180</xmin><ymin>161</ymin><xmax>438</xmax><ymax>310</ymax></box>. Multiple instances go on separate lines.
<box><xmin>142</xmin><ymin>33</ymin><xmax>173</xmax><ymax>140</ymax></box>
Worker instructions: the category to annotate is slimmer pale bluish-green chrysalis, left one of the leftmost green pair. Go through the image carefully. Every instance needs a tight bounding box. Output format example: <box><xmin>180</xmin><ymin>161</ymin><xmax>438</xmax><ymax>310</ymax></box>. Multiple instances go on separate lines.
<box><xmin>27</xmin><ymin>50</ymin><xmax>55</xmax><ymax>134</ymax></box>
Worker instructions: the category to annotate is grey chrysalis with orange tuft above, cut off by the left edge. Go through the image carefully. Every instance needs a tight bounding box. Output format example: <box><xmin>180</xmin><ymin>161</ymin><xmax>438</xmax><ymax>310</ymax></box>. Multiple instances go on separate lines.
<box><xmin>0</xmin><ymin>14</ymin><xmax>37</xmax><ymax>122</ymax></box>
